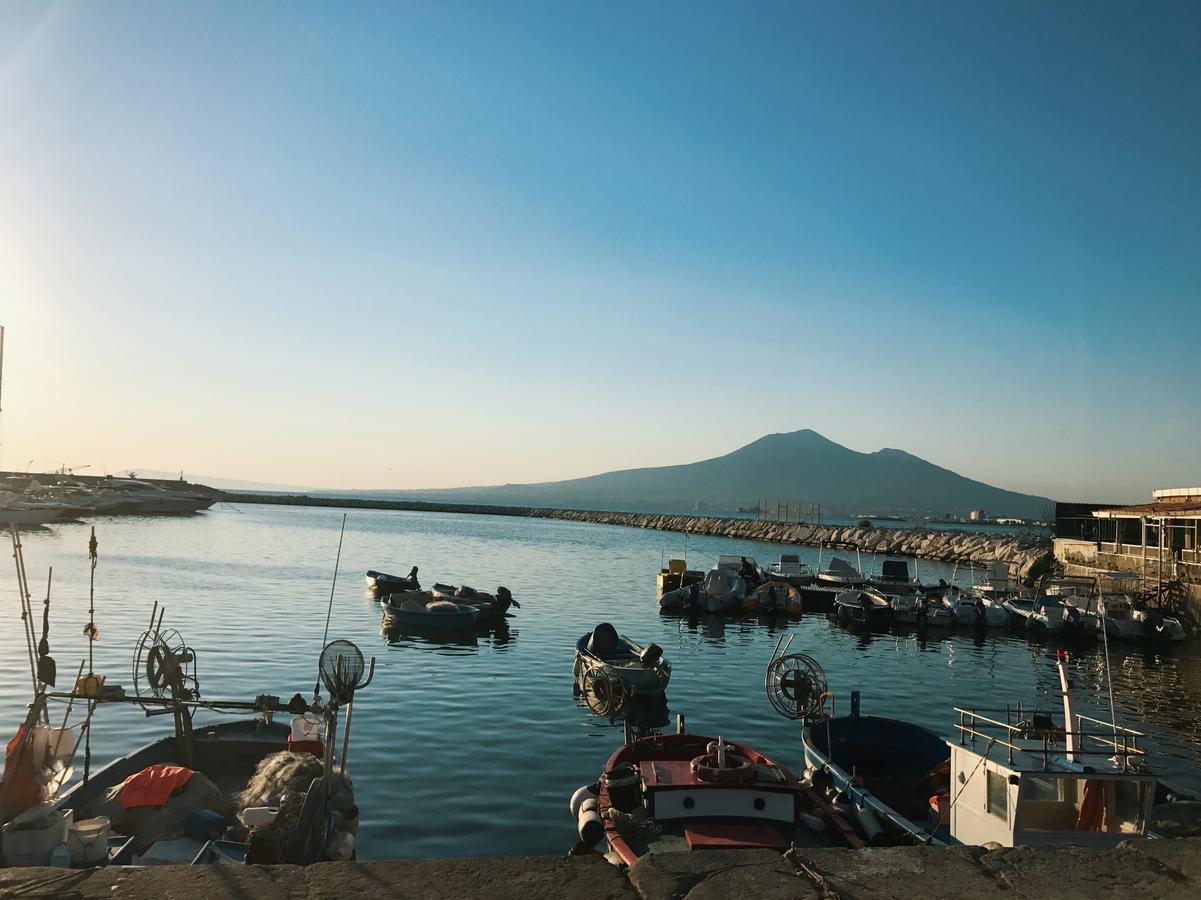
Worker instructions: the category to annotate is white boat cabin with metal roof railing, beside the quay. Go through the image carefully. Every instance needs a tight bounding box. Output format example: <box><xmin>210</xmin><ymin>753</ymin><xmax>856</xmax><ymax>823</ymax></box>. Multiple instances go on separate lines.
<box><xmin>948</xmin><ymin>709</ymin><xmax>1155</xmax><ymax>848</ymax></box>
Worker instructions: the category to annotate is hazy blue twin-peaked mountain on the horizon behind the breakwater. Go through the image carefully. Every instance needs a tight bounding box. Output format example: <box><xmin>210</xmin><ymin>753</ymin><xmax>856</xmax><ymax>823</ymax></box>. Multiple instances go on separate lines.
<box><xmin>360</xmin><ymin>429</ymin><xmax>1050</xmax><ymax>518</ymax></box>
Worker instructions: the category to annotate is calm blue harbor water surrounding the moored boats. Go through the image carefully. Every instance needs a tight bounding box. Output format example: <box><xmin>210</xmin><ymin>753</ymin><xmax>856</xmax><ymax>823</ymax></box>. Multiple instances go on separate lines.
<box><xmin>0</xmin><ymin>506</ymin><xmax>1201</xmax><ymax>857</ymax></box>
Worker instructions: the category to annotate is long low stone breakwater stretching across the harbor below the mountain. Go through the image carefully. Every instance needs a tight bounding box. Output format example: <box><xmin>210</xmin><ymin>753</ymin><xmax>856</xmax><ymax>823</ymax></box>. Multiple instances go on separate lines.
<box><xmin>216</xmin><ymin>485</ymin><xmax>1051</xmax><ymax>582</ymax></box>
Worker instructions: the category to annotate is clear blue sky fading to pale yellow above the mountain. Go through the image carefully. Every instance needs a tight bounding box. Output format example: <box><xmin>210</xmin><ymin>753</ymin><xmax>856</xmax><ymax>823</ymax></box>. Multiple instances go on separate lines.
<box><xmin>0</xmin><ymin>1</ymin><xmax>1201</xmax><ymax>500</ymax></box>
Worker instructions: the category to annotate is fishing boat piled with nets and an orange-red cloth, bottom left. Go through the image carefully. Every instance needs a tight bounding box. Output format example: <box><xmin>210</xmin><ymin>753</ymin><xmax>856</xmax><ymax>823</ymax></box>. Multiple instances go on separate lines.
<box><xmin>0</xmin><ymin>588</ymin><xmax>375</xmax><ymax>866</ymax></box>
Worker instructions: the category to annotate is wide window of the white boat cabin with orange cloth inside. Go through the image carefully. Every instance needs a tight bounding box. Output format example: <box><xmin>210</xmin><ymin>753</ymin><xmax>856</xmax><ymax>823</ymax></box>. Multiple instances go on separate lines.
<box><xmin>1017</xmin><ymin>773</ymin><xmax>1151</xmax><ymax>834</ymax></box>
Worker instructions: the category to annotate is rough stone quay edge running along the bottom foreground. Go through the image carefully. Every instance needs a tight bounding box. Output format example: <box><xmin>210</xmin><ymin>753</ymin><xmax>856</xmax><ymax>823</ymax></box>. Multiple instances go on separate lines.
<box><xmin>0</xmin><ymin>838</ymin><xmax>1201</xmax><ymax>900</ymax></box>
